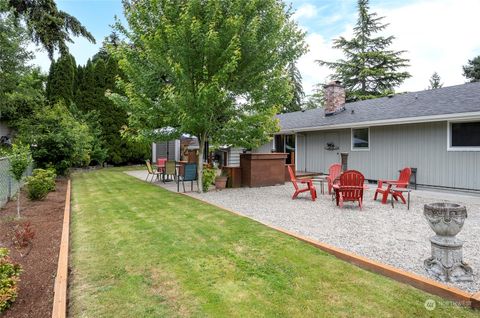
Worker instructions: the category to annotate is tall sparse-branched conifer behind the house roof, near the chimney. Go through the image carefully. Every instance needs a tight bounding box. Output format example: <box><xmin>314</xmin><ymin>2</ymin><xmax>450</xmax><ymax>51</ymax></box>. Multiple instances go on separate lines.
<box><xmin>318</xmin><ymin>0</ymin><xmax>410</xmax><ymax>101</ymax></box>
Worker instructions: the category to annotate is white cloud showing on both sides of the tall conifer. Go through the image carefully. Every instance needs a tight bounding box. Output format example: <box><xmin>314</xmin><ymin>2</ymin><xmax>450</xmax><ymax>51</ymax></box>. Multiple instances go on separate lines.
<box><xmin>297</xmin><ymin>0</ymin><xmax>480</xmax><ymax>94</ymax></box>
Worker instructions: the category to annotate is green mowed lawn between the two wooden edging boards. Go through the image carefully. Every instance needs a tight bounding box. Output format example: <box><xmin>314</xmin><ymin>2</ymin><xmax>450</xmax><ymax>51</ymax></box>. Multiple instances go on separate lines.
<box><xmin>70</xmin><ymin>169</ymin><xmax>478</xmax><ymax>318</ymax></box>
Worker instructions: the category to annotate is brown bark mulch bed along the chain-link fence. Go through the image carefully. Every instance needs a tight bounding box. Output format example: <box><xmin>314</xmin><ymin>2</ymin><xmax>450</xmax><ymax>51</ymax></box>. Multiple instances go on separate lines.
<box><xmin>0</xmin><ymin>180</ymin><xmax>67</xmax><ymax>318</ymax></box>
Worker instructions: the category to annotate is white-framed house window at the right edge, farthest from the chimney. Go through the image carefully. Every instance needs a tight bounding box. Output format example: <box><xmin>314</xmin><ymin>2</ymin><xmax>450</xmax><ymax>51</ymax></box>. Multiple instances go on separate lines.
<box><xmin>448</xmin><ymin>121</ymin><xmax>480</xmax><ymax>151</ymax></box>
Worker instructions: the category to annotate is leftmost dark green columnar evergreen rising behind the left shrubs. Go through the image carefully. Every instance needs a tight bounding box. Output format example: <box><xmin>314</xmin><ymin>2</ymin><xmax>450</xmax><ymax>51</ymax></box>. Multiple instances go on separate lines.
<box><xmin>46</xmin><ymin>54</ymin><xmax>77</xmax><ymax>106</ymax></box>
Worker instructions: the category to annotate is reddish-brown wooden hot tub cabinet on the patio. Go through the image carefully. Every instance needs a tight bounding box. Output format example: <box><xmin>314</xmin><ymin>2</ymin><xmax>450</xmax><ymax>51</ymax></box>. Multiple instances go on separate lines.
<box><xmin>240</xmin><ymin>153</ymin><xmax>287</xmax><ymax>187</ymax></box>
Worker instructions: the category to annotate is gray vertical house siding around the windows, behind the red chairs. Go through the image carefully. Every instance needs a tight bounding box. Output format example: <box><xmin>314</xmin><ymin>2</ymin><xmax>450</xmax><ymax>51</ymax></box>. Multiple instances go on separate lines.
<box><xmin>297</xmin><ymin>121</ymin><xmax>480</xmax><ymax>190</ymax></box>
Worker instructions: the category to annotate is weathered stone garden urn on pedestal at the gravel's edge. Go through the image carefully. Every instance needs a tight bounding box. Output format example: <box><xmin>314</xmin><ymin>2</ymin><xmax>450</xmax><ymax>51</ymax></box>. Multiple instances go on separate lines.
<box><xmin>423</xmin><ymin>203</ymin><xmax>473</xmax><ymax>282</ymax></box>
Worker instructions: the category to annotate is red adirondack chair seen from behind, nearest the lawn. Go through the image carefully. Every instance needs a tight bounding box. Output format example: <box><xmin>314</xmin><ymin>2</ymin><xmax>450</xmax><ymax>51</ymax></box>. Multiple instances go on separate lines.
<box><xmin>333</xmin><ymin>170</ymin><xmax>365</xmax><ymax>209</ymax></box>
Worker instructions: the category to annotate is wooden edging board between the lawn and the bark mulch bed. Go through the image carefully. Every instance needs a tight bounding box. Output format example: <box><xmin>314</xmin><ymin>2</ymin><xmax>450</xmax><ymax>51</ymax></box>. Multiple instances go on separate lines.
<box><xmin>52</xmin><ymin>179</ymin><xmax>71</xmax><ymax>318</ymax></box>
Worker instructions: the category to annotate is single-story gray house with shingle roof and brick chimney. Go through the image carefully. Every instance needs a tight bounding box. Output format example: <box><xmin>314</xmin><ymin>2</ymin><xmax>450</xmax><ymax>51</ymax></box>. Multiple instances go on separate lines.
<box><xmin>255</xmin><ymin>82</ymin><xmax>480</xmax><ymax>191</ymax></box>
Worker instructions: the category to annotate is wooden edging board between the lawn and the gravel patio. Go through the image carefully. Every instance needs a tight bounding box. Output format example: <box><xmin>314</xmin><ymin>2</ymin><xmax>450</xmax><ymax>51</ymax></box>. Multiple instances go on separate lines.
<box><xmin>176</xmin><ymin>189</ymin><xmax>480</xmax><ymax>309</ymax></box>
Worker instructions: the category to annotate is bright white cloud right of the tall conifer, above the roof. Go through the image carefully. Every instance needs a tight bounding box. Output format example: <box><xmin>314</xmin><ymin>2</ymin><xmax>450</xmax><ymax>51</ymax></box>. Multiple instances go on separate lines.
<box><xmin>372</xmin><ymin>0</ymin><xmax>480</xmax><ymax>91</ymax></box>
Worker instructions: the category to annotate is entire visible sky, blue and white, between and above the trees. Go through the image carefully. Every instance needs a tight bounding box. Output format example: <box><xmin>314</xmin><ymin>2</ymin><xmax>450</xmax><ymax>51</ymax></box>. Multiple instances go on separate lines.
<box><xmin>32</xmin><ymin>0</ymin><xmax>480</xmax><ymax>94</ymax></box>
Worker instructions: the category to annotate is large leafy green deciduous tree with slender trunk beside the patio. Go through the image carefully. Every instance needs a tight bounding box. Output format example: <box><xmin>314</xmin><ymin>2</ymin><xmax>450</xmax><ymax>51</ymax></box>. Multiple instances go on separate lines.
<box><xmin>111</xmin><ymin>0</ymin><xmax>305</xmax><ymax>191</ymax></box>
